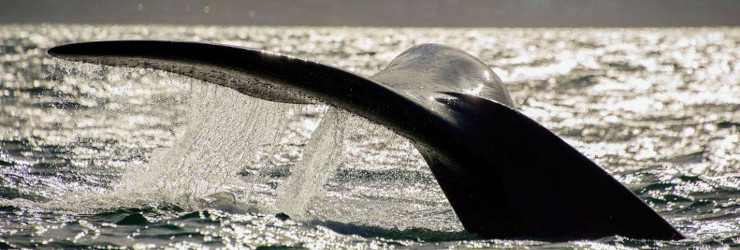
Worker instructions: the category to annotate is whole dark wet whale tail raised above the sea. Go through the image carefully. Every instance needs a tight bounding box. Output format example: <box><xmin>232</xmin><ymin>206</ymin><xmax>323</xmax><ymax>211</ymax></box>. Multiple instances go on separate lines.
<box><xmin>48</xmin><ymin>41</ymin><xmax>683</xmax><ymax>241</ymax></box>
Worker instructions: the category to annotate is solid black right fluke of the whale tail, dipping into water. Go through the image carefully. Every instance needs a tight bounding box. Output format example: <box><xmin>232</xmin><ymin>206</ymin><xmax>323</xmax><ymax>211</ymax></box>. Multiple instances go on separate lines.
<box><xmin>422</xmin><ymin>93</ymin><xmax>683</xmax><ymax>240</ymax></box>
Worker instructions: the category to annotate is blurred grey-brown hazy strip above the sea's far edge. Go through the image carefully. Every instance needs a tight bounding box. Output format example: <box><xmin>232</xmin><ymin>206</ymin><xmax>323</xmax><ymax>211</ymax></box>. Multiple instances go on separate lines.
<box><xmin>0</xmin><ymin>0</ymin><xmax>740</xmax><ymax>27</ymax></box>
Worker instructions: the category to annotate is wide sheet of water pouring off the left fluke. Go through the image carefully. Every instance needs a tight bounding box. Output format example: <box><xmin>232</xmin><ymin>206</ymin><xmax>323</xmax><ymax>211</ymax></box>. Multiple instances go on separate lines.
<box><xmin>116</xmin><ymin>84</ymin><xmax>291</xmax><ymax>210</ymax></box>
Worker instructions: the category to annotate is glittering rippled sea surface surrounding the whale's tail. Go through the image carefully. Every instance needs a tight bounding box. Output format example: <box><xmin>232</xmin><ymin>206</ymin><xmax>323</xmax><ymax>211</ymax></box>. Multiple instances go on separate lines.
<box><xmin>0</xmin><ymin>24</ymin><xmax>740</xmax><ymax>249</ymax></box>
